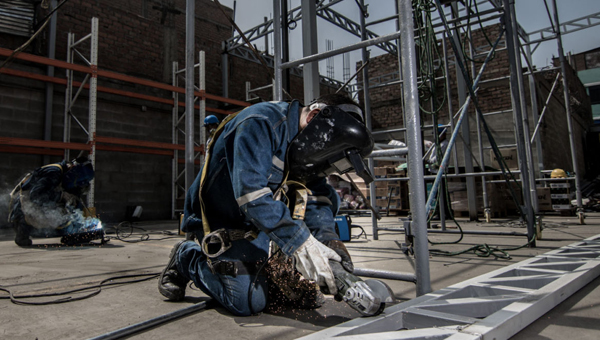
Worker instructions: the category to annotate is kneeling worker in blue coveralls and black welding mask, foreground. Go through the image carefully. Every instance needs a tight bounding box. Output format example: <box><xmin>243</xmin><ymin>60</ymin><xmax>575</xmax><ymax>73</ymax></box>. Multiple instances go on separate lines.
<box><xmin>158</xmin><ymin>94</ymin><xmax>373</xmax><ymax>315</ymax></box>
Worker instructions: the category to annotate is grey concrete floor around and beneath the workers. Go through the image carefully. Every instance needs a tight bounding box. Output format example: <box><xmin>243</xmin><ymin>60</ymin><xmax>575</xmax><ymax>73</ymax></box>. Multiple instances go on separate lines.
<box><xmin>0</xmin><ymin>213</ymin><xmax>600</xmax><ymax>340</ymax></box>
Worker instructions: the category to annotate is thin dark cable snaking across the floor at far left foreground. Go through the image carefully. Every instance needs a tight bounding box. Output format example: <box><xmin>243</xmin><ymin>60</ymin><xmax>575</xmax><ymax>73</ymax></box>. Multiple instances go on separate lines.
<box><xmin>0</xmin><ymin>273</ymin><xmax>160</xmax><ymax>306</ymax></box>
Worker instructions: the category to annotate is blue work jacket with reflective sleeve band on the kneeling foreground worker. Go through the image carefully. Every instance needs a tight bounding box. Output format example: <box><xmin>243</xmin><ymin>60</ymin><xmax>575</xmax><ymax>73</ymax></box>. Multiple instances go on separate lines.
<box><xmin>182</xmin><ymin>101</ymin><xmax>339</xmax><ymax>256</ymax></box>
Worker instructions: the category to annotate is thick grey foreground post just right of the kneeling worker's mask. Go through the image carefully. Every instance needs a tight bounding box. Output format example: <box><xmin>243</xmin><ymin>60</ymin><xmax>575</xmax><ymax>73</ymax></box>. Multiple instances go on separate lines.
<box><xmin>398</xmin><ymin>0</ymin><xmax>431</xmax><ymax>296</ymax></box>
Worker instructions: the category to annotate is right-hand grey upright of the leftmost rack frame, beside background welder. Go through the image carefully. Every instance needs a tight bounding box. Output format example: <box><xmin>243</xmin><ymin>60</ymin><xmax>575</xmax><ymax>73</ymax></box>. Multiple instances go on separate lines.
<box><xmin>87</xmin><ymin>18</ymin><xmax>98</xmax><ymax>207</ymax></box>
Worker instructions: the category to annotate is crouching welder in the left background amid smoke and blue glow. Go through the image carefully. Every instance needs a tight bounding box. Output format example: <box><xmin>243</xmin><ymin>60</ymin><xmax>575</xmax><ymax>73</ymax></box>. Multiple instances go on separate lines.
<box><xmin>8</xmin><ymin>157</ymin><xmax>100</xmax><ymax>246</ymax></box>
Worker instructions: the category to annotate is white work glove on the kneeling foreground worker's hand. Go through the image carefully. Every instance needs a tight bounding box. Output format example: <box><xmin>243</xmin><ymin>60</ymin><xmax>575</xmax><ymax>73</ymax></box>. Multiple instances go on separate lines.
<box><xmin>294</xmin><ymin>235</ymin><xmax>342</xmax><ymax>295</ymax></box>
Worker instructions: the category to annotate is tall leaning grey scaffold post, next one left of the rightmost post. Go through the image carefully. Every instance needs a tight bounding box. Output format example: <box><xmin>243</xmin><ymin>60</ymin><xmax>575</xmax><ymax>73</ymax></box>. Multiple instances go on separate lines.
<box><xmin>503</xmin><ymin>0</ymin><xmax>535</xmax><ymax>247</ymax></box>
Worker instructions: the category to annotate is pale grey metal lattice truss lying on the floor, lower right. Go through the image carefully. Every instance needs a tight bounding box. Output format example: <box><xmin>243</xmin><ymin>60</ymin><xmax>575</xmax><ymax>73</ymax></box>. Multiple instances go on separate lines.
<box><xmin>302</xmin><ymin>235</ymin><xmax>600</xmax><ymax>340</ymax></box>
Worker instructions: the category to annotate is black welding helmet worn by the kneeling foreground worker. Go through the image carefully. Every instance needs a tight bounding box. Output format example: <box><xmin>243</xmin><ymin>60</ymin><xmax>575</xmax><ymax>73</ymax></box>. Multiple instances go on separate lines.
<box><xmin>286</xmin><ymin>104</ymin><xmax>374</xmax><ymax>184</ymax></box>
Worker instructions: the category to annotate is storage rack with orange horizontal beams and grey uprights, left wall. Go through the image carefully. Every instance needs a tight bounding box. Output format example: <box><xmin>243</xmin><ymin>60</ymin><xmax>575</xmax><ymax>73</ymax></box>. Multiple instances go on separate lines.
<box><xmin>0</xmin><ymin>18</ymin><xmax>250</xmax><ymax>218</ymax></box>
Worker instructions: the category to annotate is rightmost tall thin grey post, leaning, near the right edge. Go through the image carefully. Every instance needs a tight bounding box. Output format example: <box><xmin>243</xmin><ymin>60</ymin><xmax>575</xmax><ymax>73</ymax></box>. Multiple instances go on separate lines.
<box><xmin>552</xmin><ymin>0</ymin><xmax>583</xmax><ymax>216</ymax></box>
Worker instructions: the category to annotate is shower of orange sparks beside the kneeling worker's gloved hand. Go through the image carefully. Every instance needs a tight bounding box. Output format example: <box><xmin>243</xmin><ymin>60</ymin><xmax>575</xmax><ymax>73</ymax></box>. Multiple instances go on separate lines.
<box><xmin>266</xmin><ymin>252</ymin><xmax>325</xmax><ymax>310</ymax></box>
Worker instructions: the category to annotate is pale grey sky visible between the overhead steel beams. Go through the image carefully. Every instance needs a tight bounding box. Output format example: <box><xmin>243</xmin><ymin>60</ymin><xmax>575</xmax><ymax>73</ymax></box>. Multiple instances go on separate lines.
<box><xmin>220</xmin><ymin>0</ymin><xmax>600</xmax><ymax>81</ymax></box>
